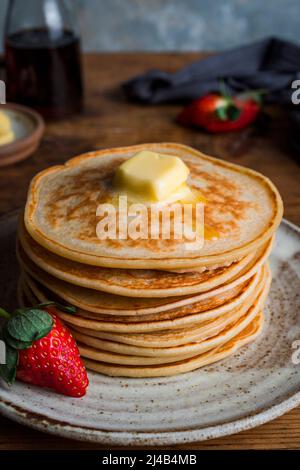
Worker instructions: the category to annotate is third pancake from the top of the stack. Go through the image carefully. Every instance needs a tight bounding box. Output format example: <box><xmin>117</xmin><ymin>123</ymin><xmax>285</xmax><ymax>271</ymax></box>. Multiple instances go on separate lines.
<box><xmin>17</xmin><ymin>234</ymin><xmax>271</xmax><ymax>312</ymax></box>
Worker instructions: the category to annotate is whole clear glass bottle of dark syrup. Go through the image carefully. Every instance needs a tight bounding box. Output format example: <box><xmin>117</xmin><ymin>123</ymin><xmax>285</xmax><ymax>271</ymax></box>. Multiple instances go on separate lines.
<box><xmin>5</xmin><ymin>0</ymin><xmax>83</xmax><ymax>119</ymax></box>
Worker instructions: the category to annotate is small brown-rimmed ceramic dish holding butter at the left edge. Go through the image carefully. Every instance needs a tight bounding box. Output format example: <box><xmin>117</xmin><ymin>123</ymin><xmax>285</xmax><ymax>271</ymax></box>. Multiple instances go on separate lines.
<box><xmin>0</xmin><ymin>103</ymin><xmax>45</xmax><ymax>167</ymax></box>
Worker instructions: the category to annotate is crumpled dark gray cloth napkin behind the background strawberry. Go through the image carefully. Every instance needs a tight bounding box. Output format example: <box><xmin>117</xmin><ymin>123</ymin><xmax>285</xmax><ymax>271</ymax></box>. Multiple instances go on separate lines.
<box><xmin>123</xmin><ymin>38</ymin><xmax>300</xmax><ymax>104</ymax></box>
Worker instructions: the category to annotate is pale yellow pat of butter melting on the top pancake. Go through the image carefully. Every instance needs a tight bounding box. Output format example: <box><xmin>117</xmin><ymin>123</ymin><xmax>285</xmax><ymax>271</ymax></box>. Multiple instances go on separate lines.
<box><xmin>114</xmin><ymin>150</ymin><xmax>189</xmax><ymax>202</ymax></box>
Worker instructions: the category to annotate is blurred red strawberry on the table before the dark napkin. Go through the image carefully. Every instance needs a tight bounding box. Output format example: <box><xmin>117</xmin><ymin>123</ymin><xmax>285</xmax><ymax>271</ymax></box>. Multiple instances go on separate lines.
<box><xmin>177</xmin><ymin>92</ymin><xmax>261</xmax><ymax>133</ymax></box>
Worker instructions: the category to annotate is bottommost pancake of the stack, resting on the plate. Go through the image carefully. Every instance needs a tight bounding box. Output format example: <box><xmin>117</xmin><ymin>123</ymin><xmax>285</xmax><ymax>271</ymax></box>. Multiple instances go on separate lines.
<box><xmin>83</xmin><ymin>312</ymin><xmax>264</xmax><ymax>378</ymax></box>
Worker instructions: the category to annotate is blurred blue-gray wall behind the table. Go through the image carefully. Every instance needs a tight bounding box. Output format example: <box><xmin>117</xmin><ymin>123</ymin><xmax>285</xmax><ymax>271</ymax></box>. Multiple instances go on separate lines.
<box><xmin>0</xmin><ymin>0</ymin><xmax>300</xmax><ymax>51</ymax></box>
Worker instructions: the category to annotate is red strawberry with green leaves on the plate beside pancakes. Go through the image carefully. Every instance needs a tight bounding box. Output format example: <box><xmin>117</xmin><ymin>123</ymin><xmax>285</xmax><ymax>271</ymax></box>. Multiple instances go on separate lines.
<box><xmin>0</xmin><ymin>302</ymin><xmax>89</xmax><ymax>397</ymax></box>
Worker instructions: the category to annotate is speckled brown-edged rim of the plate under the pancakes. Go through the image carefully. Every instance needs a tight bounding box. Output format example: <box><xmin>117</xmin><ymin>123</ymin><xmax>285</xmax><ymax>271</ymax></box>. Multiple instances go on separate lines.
<box><xmin>0</xmin><ymin>219</ymin><xmax>300</xmax><ymax>446</ymax></box>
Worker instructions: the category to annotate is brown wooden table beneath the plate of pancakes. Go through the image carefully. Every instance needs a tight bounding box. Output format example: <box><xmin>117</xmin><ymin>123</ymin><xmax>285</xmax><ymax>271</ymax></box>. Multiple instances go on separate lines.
<box><xmin>0</xmin><ymin>53</ymin><xmax>300</xmax><ymax>449</ymax></box>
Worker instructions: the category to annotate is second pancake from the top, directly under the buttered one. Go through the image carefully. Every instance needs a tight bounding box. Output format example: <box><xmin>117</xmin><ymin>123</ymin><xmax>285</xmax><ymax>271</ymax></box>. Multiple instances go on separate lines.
<box><xmin>19</xmin><ymin>223</ymin><xmax>271</xmax><ymax>298</ymax></box>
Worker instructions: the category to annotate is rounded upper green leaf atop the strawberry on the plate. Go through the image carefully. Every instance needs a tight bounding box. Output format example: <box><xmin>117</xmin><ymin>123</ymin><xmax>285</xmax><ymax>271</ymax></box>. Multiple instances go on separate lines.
<box><xmin>5</xmin><ymin>308</ymin><xmax>53</xmax><ymax>343</ymax></box>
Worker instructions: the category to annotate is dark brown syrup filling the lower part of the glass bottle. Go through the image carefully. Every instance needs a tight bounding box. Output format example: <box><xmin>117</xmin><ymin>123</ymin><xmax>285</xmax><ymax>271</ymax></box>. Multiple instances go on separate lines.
<box><xmin>5</xmin><ymin>28</ymin><xmax>83</xmax><ymax>119</ymax></box>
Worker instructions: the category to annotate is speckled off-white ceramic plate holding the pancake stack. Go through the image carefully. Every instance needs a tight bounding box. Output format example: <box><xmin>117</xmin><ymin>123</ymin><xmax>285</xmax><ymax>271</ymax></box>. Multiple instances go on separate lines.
<box><xmin>0</xmin><ymin>211</ymin><xmax>300</xmax><ymax>445</ymax></box>
